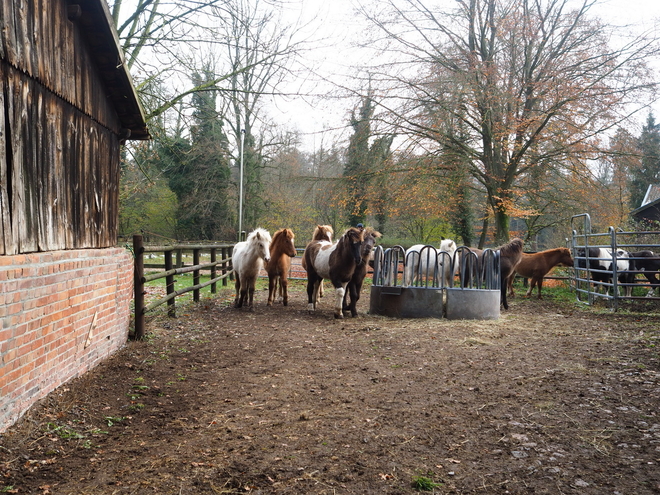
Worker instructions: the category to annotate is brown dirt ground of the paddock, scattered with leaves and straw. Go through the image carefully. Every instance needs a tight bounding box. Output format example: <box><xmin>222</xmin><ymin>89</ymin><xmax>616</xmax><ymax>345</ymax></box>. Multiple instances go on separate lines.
<box><xmin>0</xmin><ymin>285</ymin><xmax>660</xmax><ymax>495</ymax></box>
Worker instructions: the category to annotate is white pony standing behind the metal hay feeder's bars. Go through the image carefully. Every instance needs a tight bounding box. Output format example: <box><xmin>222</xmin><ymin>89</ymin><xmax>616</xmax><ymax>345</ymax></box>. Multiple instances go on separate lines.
<box><xmin>404</xmin><ymin>239</ymin><xmax>458</xmax><ymax>287</ymax></box>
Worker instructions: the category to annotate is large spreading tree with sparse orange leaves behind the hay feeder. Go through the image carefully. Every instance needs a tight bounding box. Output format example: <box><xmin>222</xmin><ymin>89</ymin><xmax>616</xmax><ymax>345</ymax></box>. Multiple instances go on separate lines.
<box><xmin>363</xmin><ymin>0</ymin><xmax>656</xmax><ymax>243</ymax></box>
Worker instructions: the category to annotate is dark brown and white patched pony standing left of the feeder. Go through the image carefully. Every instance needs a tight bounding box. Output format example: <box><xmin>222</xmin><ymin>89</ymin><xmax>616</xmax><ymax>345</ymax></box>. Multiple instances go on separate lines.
<box><xmin>303</xmin><ymin>227</ymin><xmax>364</xmax><ymax>318</ymax></box>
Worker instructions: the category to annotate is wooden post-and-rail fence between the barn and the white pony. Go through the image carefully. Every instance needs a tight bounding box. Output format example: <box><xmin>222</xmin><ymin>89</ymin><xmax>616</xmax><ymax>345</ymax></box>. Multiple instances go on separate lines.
<box><xmin>133</xmin><ymin>235</ymin><xmax>234</xmax><ymax>339</ymax></box>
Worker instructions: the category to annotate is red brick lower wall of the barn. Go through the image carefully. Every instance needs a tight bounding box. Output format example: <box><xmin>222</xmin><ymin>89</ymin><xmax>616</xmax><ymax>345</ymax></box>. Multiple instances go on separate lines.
<box><xmin>0</xmin><ymin>248</ymin><xmax>133</xmax><ymax>432</ymax></box>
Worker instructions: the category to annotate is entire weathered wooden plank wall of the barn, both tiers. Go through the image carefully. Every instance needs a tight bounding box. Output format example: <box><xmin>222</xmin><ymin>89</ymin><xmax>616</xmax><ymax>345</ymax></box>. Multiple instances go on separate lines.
<box><xmin>0</xmin><ymin>0</ymin><xmax>120</xmax><ymax>255</ymax></box>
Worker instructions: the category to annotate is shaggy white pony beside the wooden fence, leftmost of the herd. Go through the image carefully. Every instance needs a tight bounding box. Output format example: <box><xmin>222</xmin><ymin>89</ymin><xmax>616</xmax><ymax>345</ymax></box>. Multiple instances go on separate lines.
<box><xmin>232</xmin><ymin>228</ymin><xmax>271</xmax><ymax>309</ymax></box>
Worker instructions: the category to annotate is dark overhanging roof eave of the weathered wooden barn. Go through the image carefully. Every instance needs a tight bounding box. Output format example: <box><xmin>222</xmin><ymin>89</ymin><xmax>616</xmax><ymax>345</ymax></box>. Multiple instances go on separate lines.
<box><xmin>76</xmin><ymin>0</ymin><xmax>150</xmax><ymax>140</ymax></box>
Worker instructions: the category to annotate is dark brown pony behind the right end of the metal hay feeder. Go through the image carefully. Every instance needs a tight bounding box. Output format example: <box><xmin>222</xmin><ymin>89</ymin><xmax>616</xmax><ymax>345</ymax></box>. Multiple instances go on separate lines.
<box><xmin>457</xmin><ymin>237</ymin><xmax>523</xmax><ymax>309</ymax></box>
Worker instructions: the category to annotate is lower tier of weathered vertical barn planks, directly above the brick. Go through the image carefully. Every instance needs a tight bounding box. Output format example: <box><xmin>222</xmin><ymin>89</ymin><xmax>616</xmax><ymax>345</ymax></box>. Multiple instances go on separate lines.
<box><xmin>0</xmin><ymin>61</ymin><xmax>120</xmax><ymax>254</ymax></box>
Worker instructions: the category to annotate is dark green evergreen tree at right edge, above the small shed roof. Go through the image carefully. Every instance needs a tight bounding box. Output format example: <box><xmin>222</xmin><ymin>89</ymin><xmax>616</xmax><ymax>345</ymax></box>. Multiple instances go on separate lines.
<box><xmin>630</xmin><ymin>113</ymin><xmax>660</xmax><ymax>209</ymax></box>
